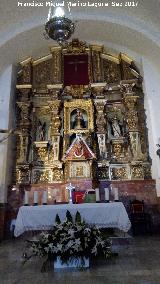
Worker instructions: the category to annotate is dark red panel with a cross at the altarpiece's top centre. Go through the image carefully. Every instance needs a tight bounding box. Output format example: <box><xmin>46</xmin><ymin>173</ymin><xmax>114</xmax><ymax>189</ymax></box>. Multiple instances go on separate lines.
<box><xmin>64</xmin><ymin>54</ymin><xmax>89</xmax><ymax>86</ymax></box>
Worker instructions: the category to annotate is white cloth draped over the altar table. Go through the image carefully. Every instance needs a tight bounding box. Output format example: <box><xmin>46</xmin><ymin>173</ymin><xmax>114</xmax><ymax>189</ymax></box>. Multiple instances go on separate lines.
<box><xmin>14</xmin><ymin>202</ymin><xmax>131</xmax><ymax>237</ymax></box>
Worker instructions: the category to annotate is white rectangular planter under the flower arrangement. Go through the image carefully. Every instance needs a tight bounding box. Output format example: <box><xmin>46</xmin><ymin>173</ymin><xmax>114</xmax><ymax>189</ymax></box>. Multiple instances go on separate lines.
<box><xmin>54</xmin><ymin>256</ymin><xmax>89</xmax><ymax>269</ymax></box>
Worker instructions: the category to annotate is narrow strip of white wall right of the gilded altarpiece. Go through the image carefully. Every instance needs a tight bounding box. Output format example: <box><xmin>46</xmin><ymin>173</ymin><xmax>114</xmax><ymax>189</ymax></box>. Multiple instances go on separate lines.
<box><xmin>142</xmin><ymin>58</ymin><xmax>160</xmax><ymax>196</ymax></box>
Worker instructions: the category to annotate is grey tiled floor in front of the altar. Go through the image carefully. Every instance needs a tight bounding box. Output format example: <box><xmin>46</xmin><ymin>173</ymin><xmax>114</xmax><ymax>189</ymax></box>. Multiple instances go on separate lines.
<box><xmin>0</xmin><ymin>236</ymin><xmax>160</xmax><ymax>284</ymax></box>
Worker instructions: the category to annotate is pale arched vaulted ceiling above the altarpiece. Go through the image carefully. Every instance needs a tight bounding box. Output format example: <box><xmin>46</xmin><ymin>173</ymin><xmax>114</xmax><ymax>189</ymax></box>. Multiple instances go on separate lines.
<box><xmin>0</xmin><ymin>0</ymin><xmax>160</xmax><ymax>71</ymax></box>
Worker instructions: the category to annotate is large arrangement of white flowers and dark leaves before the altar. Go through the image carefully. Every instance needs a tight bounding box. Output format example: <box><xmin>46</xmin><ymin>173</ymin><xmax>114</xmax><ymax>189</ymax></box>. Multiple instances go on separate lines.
<box><xmin>25</xmin><ymin>211</ymin><xmax>111</xmax><ymax>266</ymax></box>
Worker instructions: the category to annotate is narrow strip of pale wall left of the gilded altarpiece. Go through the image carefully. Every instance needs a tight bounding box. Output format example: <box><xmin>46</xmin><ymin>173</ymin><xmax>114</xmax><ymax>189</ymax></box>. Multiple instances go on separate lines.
<box><xmin>0</xmin><ymin>65</ymin><xmax>15</xmax><ymax>240</ymax></box>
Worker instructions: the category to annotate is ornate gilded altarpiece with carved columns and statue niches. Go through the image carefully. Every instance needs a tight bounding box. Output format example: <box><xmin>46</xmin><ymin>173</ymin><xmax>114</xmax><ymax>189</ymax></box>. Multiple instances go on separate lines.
<box><xmin>13</xmin><ymin>39</ymin><xmax>150</xmax><ymax>201</ymax></box>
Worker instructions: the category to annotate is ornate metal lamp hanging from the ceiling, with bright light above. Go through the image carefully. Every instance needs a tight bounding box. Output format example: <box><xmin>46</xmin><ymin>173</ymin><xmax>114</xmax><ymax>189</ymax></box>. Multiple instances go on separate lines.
<box><xmin>45</xmin><ymin>7</ymin><xmax>75</xmax><ymax>45</ymax></box>
